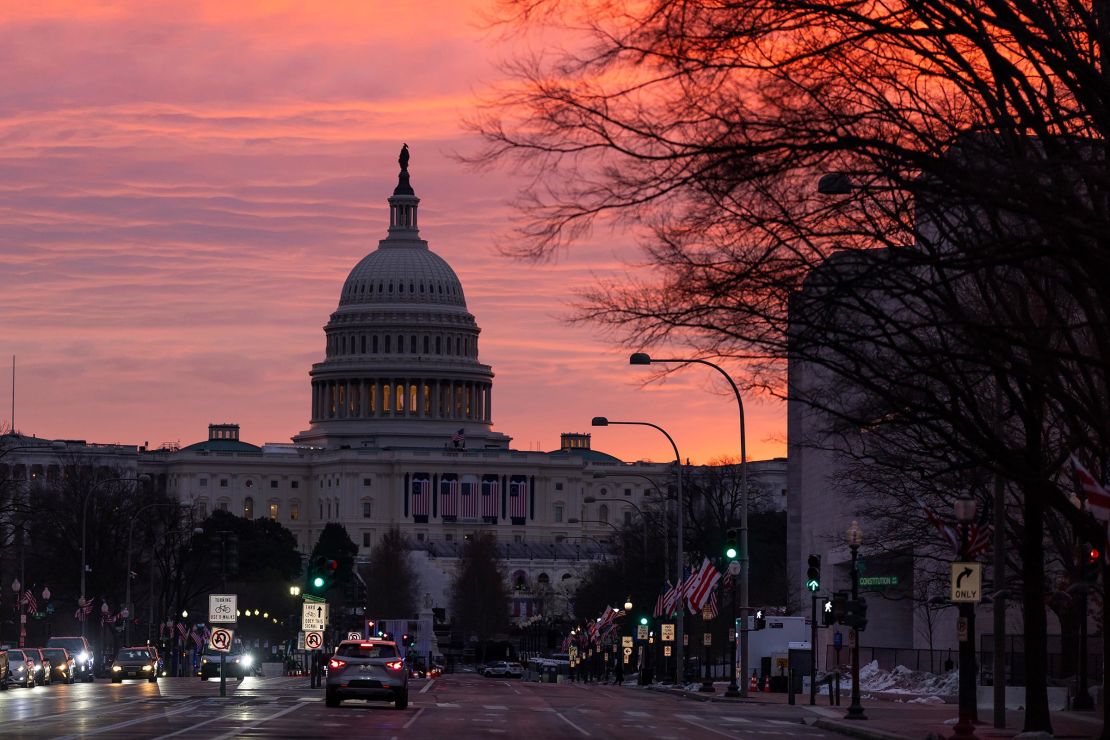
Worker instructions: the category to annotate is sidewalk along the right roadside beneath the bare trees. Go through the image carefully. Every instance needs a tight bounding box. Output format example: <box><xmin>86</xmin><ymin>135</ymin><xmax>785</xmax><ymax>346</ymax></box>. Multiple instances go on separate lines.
<box><xmin>647</xmin><ymin>682</ymin><xmax>1102</xmax><ymax>740</ymax></box>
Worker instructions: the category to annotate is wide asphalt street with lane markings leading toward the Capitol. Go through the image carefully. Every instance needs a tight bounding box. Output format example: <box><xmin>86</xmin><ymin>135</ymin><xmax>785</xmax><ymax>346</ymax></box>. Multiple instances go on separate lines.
<box><xmin>0</xmin><ymin>673</ymin><xmax>840</xmax><ymax>740</ymax></box>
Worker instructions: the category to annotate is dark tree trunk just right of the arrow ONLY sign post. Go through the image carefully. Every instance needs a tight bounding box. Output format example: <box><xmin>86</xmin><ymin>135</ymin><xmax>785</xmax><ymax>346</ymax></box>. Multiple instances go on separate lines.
<box><xmin>1021</xmin><ymin>485</ymin><xmax>1052</xmax><ymax>734</ymax></box>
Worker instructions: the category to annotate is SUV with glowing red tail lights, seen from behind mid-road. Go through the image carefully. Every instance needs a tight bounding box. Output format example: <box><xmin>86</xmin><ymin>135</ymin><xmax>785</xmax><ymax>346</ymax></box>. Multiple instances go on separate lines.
<box><xmin>324</xmin><ymin>640</ymin><xmax>408</xmax><ymax>709</ymax></box>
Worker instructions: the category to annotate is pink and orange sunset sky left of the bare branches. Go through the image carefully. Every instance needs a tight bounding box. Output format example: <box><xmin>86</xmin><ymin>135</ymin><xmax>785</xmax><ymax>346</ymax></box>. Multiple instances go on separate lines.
<box><xmin>0</xmin><ymin>0</ymin><xmax>785</xmax><ymax>462</ymax></box>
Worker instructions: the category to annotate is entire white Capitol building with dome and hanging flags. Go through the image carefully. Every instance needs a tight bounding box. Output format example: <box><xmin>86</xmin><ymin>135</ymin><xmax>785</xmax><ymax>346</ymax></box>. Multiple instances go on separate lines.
<box><xmin>4</xmin><ymin>146</ymin><xmax>786</xmax><ymax>621</ymax></box>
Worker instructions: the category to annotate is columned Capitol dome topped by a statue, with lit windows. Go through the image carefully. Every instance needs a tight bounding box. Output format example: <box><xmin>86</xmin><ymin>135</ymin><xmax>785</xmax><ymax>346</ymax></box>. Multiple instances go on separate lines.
<box><xmin>294</xmin><ymin>144</ymin><xmax>509</xmax><ymax>448</ymax></box>
